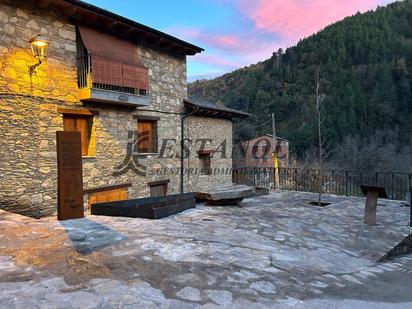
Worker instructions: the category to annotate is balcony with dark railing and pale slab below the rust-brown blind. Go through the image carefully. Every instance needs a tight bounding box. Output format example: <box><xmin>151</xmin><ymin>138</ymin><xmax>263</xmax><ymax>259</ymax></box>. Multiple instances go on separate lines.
<box><xmin>77</xmin><ymin>54</ymin><xmax>150</xmax><ymax>107</ymax></box>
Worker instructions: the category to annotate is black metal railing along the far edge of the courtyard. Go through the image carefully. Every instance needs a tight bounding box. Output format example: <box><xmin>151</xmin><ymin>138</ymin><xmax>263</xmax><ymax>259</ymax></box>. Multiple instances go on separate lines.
<box><xmin>233</xmin><ymin>167</ymin><xmax>412</xmax><ymax>200</ymax></box>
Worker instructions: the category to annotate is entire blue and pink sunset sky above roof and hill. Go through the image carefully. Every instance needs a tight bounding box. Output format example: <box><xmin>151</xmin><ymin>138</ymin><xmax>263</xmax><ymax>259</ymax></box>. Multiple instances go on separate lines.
<box><xmin>86</xmin><ymin>0</ymin><xmax>395</xmax><ymax>80</ymax></box>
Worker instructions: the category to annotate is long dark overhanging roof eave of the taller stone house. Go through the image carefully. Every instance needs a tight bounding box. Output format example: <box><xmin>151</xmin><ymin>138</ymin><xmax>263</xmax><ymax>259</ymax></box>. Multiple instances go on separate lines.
<box><xmin>48</xmin><ymin>0</ymin><xmax>204</xmax><ymax>55</ymax></box>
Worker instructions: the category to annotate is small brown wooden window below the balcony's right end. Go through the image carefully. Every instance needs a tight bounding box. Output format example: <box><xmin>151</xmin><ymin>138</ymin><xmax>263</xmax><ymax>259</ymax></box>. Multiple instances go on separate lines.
<box><xmin>137</xmin><ymin>119</ymin><xmax>157</xmax><ymax>154</ymax></box>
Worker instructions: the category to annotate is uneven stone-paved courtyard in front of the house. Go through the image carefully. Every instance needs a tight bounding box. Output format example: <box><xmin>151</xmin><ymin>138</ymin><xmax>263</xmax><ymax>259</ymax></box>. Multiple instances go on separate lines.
<box><xmin>0</xmin><ymin>192</ymin><xmax>412</xmax><ymax>308</ymax></box>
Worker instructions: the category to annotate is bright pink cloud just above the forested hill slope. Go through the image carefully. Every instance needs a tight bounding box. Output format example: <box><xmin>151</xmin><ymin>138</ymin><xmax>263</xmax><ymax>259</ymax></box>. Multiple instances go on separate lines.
<box><xmin>239</xmin><ymin>0</ymin><xmax>389</xmax><ymax>41</ymax></box>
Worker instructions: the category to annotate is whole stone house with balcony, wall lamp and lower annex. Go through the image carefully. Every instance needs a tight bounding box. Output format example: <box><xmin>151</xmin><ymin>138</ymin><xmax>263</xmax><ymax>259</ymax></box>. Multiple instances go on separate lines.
<box><xmin>0</xmin><ymin>0</ymin><xmax>248</xmax><ymax>217</ymax></box>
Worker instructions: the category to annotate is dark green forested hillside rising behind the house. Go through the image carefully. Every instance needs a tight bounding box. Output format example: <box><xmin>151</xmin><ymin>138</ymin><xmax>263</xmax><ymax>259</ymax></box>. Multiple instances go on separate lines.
<box><xmin>189</xmin><ymin>0</ymin><xmax>412</xmax><ymax>170</ymax></box>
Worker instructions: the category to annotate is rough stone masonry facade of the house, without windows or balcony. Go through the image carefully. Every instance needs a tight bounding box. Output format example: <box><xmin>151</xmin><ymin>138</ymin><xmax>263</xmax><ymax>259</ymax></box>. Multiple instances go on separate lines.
<box><xmin>0</xmin><ymin>0</ymin><xmax>232</xmax><ymax>217</ymax></box>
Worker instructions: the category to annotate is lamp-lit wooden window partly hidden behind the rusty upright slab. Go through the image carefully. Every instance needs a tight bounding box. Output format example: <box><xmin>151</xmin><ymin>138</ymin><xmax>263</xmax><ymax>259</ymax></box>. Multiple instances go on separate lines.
<box><xmin>63</xmin><ymin>114</ymin><xmax>94</xmax><ymax>156</ymax></box>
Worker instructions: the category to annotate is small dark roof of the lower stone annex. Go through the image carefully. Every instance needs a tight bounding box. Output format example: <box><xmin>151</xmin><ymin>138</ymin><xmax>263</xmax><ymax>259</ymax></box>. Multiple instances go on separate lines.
<box><xmin>184</xmin><ymin>99</ymin><xmax>251</xmax><ymax>119</ymax></box>
